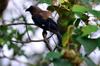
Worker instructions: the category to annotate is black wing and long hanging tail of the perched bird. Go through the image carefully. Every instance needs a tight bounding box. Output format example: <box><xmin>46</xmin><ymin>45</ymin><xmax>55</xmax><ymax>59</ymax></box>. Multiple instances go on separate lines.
<box><xmin>32</xmin><ymin>16</ymin><xmax>62</xmax><ymax>46</ymax></box>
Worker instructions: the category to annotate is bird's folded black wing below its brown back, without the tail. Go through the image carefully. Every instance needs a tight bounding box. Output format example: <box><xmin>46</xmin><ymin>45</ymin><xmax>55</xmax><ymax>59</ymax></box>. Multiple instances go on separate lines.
<box><xmin>32</xmin><ymin>15</ymin><xmax>58</xmax><ymax>32</ymax></box>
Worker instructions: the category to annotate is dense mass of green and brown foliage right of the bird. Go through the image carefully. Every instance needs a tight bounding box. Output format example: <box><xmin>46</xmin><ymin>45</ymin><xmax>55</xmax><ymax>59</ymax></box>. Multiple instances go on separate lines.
<box><xmin>41</xmin><ymin>0</ymin><xmax>100</xmax><ymax>66</ymax></box>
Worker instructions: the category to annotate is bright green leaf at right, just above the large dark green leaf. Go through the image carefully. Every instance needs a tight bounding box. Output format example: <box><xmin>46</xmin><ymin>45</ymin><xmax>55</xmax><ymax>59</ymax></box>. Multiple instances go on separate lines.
<box><xmin>82</xmin><ymin>25</ymin><xmax>98</xmax><ymax>36</ymax></box>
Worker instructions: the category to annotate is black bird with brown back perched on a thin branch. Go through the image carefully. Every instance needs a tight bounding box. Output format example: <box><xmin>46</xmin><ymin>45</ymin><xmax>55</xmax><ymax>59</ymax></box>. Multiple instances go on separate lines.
<box><xmin>26</xmin><ymin>6</ymin><xmax>62</xmax><ymax>47</ymax></box>
